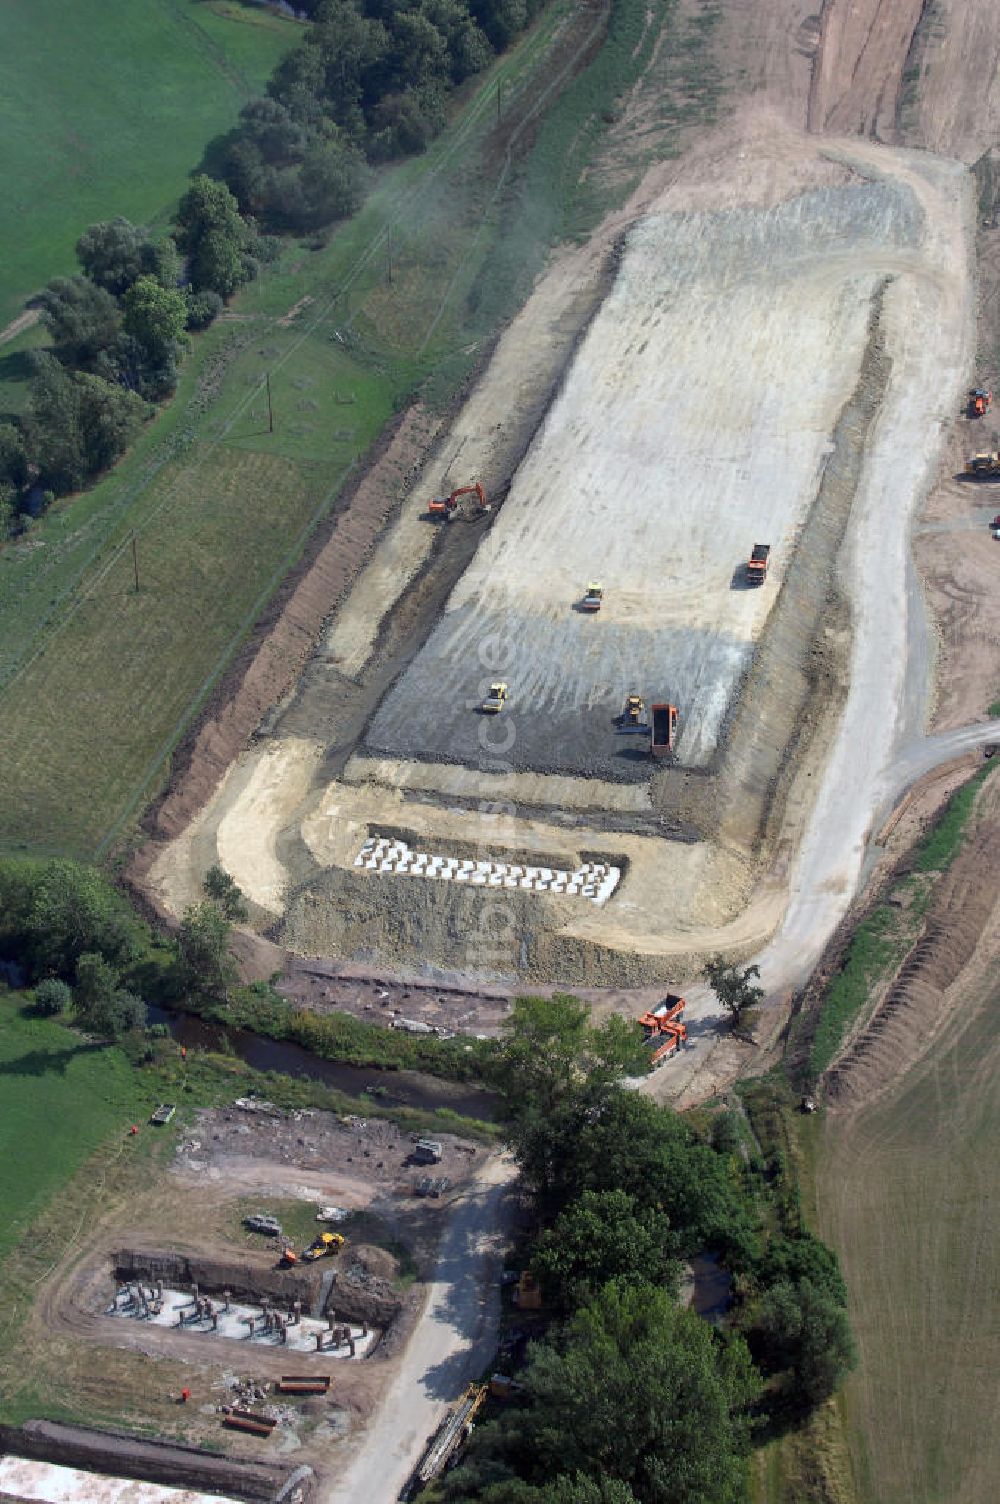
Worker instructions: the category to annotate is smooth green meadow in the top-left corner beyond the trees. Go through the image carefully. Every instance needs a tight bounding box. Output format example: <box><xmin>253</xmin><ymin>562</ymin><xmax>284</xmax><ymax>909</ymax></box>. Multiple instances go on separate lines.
<box><xmin>0</xmin><ymin>0</ymin><xmax>302</xmax><ymax>332</ymax></box>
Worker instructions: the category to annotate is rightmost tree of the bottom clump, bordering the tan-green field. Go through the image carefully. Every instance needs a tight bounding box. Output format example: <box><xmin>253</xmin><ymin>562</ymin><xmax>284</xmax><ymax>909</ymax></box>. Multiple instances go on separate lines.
<box><xmin>756</xmin><ymin>1280</ymin><xmax>857</xmax><ymax>1406</ymax></box>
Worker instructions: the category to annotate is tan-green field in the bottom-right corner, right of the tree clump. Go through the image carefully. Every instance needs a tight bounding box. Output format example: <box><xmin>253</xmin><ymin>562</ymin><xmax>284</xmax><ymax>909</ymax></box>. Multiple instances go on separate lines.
<box><xmin>818</xmin><ymin>978</ymin><xmax>1000</xmax><ymax>1504</ymax></box>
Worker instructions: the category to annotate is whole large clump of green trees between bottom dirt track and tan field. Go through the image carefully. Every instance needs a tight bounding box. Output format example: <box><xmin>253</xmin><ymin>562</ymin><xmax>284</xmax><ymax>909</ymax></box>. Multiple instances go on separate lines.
<box><xmin>436</xmin><ymin>997</ymin><xmax>853</xmax><ymax>1504</ymax></box>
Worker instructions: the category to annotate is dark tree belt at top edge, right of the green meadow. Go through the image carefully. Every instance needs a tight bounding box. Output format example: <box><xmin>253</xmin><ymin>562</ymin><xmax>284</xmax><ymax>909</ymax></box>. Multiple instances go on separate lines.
<box><xmin>224</xmin><ymin>0</ymin><xmax>541</xmax><ymax>232</ymax></box>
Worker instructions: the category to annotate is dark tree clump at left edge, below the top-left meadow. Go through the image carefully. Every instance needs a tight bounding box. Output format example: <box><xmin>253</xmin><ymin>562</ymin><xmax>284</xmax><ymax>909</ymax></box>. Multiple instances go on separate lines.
<box><xmin>0</xmin><ymin>176</ymin><xmax>266</xmax><ymax>541</ymax></box>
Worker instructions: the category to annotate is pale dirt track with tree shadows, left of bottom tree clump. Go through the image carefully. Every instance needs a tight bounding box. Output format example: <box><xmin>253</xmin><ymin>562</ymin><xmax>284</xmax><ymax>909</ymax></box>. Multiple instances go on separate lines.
<box><xmin>319</xmin><ymin>1157</ymin><xmax>516</xmax><ymax>1504</ymax></box>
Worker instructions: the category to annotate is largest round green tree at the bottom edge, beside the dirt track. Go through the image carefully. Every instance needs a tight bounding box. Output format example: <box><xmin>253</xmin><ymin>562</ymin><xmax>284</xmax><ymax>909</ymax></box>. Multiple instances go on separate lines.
<box><xmin>507</xmin><ymin>1280</ymin><xmax>759</xmax><ymax>1504</ymax></box>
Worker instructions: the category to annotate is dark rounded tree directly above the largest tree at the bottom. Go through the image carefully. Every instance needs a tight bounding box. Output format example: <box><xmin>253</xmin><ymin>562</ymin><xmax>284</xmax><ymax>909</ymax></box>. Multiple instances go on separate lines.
<box><xmin>531</xmin><ymin>1190</ymin><xmax>681</xmax><ymax>1311</ymax></box>
